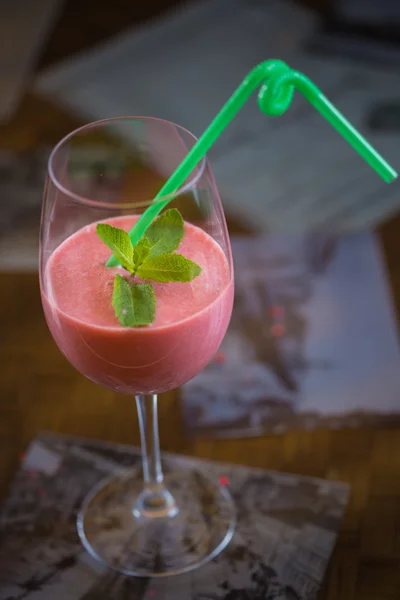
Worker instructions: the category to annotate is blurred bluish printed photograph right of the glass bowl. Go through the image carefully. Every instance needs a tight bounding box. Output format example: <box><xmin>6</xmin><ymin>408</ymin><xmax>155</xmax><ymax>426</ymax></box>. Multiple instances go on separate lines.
<box><xmin>182</xmin><ymin>233</ymin><xmax>400</xmax><ymax>436</ymax></box>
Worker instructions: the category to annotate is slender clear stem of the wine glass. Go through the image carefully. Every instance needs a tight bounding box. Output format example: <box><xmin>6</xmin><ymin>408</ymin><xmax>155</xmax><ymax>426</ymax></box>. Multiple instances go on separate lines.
<box><xmin>134</xmin><ymin>394</ymin><xmax>177</xmax><ymax>517</ymax></box>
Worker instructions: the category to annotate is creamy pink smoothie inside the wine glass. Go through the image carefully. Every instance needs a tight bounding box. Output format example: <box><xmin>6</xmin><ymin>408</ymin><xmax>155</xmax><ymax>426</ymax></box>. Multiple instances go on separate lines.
<box><xmin>42</xmin><ymin>217</ymin><xmax>233</xmax><ymax>394</ymax></box>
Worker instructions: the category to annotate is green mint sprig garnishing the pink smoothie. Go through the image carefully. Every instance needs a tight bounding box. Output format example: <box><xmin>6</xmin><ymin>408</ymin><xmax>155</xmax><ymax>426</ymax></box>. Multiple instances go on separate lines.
<box><xmin>96</xmin><ymin>208</ymin><xmax>201</xmax><ymax>327</ymax></box>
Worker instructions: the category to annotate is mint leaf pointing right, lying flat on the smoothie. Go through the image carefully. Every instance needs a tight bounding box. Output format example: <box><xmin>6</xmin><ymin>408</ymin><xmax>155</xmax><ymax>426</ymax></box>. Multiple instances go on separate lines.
<box><xmin>136</xmin><ymin>254</ymin><xmax>201</xmax><ymax>283</ymax></box>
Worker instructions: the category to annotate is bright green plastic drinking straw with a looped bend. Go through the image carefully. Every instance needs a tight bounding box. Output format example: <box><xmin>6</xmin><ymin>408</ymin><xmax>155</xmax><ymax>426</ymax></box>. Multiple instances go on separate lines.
<box><xmin>106</xmin><ymin>60</ymin><xmax>397</xmax><ymax>267</ymax></box>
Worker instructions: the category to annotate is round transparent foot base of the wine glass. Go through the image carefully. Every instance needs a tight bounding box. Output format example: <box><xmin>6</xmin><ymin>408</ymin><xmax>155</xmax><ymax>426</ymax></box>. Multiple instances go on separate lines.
<box><xmin>78</xmin><ymin>470</ymin><xmax>236</xmax><ymax>577</ymax></box>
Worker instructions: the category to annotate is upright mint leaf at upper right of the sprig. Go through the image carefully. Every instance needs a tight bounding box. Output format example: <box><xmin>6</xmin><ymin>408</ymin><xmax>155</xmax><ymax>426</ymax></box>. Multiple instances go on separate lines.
<box><xmin>145</xmin><ymin>208</ymin><xmax>184</xmax><ymax>256</ymax></box>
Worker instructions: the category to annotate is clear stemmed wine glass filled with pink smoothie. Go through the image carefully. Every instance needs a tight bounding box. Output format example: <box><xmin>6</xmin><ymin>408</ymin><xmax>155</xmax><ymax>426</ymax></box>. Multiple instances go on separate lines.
<box><xmin>40</xmin><ymin>117</ymin><xmax>235</xmax><ymax>577</ymax></box>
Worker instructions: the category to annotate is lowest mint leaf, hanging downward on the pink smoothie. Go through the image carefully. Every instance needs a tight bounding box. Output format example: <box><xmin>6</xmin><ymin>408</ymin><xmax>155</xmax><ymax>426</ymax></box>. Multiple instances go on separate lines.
<box><xmin>112</xmin><ymin>274</ymin><xmax>156</xmax><ymax>327</ymax></box>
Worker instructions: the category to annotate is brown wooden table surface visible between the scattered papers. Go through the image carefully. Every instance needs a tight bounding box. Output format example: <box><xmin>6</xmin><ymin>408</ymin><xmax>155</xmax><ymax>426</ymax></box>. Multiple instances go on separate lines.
<box><xmin>0</xmin><ymin>0</ymin><xmax>400</xmax><ymax>600</ymax></box>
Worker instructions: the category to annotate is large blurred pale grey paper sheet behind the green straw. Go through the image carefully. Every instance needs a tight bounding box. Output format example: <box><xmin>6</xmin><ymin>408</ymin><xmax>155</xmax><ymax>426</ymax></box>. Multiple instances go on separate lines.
<box><xmin>36</xmin><ymin>0</ymin><xmax>400</xmax><ymax>232</ymax></box>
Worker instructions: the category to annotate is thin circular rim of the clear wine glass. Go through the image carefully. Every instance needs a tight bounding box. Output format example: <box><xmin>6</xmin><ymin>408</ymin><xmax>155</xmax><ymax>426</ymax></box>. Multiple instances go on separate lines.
<box><xmin>47</xmin><ymin>116</ymin><xmax>207</xmax><ymax>210</ymax></box>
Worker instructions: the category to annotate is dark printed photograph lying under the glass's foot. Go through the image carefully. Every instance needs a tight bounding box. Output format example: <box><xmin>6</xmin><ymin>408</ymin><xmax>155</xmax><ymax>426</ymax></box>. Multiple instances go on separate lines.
<box><xmin>0</xmin><ymin>436</ymin><xmax>348</xmax><ymax>600</ymax></box>
